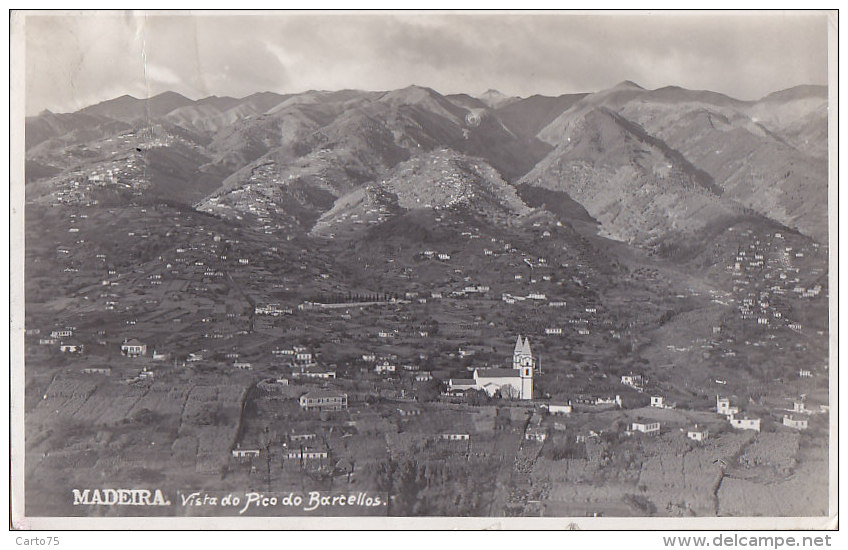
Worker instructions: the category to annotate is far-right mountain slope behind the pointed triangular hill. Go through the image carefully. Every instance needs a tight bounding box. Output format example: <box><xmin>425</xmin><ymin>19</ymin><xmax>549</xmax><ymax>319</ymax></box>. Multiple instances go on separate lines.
<box><xmin>539</xmin><ymin>83</ymin><xmax>827</xmax><ymax>242</ymax></box>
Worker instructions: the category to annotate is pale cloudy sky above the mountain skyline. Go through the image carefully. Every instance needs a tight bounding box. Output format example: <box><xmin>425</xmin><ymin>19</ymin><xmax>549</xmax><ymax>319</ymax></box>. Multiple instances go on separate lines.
<box><xmin>23</xmin><ymin>11</ymin><xmax>828</xmax><ymax>115</ymax></box>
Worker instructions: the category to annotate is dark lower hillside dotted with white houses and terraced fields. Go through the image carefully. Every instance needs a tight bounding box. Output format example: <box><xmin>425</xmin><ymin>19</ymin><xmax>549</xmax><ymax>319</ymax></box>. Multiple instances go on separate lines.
<box><xmin>26</xmin><ymin>197</ymin><xmax>829</xmax><ymax>516</ymax></box>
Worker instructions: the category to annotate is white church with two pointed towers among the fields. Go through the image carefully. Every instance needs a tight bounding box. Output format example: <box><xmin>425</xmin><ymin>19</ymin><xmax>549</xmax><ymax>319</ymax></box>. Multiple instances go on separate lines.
<box><xmin>448</xmin><ymin>334</ymin><xmax>535</xmax><ymax>399</ymax></box>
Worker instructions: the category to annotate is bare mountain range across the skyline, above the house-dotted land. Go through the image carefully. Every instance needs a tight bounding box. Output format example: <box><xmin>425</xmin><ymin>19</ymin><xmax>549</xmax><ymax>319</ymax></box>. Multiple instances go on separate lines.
<box><xmin>26</xmin><ymin>81</ymin><xmax>826</xmax><ymax>246</ymax></box>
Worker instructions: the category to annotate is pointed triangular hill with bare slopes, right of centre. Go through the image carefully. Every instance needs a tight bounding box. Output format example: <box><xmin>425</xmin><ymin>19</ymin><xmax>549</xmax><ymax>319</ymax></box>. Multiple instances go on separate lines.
<box><xmin>521</xmin><ymin>108</ymin><xmax>744</xmax><ymax>258</ymax></box>
